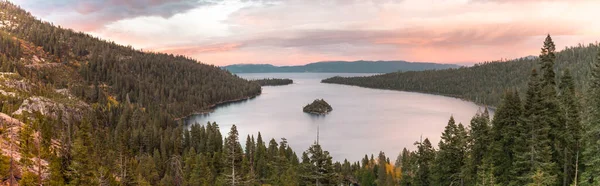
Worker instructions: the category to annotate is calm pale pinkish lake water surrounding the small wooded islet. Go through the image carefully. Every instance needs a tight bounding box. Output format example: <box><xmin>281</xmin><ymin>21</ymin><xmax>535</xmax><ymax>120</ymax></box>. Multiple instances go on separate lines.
<box><xmin>188</xmin><ymin>73</ymin><xmax>488</xmax><ymax>161</ymax></box>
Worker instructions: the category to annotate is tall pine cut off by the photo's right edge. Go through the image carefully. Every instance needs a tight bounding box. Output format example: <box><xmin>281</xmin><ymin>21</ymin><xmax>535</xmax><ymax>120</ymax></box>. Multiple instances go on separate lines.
<box><xmin>580</xmin><ymin>47</ymin><xmax>600</xmax><ymax>186</ymax></box>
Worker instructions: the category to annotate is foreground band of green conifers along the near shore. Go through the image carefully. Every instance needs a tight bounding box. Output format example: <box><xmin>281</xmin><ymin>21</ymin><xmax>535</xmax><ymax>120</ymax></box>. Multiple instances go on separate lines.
<box><xmin>5</xmin><ymin>33</ymin><xmax>600</xmax><ymax>185</ymax></box>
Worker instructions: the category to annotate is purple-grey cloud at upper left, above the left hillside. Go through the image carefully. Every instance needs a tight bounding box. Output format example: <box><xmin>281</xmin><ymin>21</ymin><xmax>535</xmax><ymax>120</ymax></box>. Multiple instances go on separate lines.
<box><xmin>17</xmin><ymin>0</ymin><xmax>220</xmax><ymax>31</ymax></box>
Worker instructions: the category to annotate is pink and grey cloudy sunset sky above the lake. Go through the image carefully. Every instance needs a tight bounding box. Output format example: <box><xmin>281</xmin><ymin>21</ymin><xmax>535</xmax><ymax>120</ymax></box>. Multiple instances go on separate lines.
<box><xmin>13</xmin><ymin>0</ymin><xmax>600</xmax><ymax>66</ymax></box>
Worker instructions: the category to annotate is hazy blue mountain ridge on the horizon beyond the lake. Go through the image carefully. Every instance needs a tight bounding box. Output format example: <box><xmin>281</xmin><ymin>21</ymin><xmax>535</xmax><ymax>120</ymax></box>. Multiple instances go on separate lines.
<box><xmin>223</xmin><ymin>61</ymin><xmax>461</xmax><ymax>73</ymax></box>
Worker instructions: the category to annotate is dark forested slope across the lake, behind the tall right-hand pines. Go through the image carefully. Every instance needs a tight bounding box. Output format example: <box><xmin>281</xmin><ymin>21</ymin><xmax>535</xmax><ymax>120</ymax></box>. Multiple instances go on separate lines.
<box><xmin>322</xmin><ymin>44</ymin><xmax>598</xmax><ymax>106</ymax></box>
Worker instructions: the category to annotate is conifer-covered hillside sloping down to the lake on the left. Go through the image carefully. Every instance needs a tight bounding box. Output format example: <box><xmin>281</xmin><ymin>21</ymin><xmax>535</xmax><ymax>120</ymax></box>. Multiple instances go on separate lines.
<box><xmin>0</xmin><ymin>3</ymin><xmax>260</xmax><ymax>117</ymax></box>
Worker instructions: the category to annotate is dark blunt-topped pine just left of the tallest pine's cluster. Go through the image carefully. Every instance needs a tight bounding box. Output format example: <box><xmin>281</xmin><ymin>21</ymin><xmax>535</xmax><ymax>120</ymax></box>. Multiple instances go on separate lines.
<box><xmin>490</xmin><ymin>91</ymin><xmax>523</xmax><ymax>185</ymax></box>
